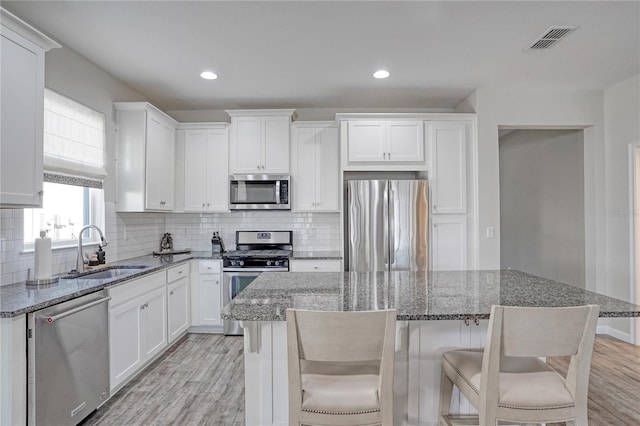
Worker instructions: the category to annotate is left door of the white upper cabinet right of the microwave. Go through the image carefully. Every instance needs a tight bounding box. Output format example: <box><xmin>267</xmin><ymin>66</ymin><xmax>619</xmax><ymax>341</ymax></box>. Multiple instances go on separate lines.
<box><xmin>291</xmin><ymin>127</ymin><xmax>318</xmax><ymax>211</ymax></box>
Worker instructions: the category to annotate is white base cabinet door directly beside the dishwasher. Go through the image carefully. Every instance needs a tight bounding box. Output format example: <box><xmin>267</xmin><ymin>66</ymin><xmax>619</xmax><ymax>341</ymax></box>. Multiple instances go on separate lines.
<box><xmin>109</xmin><ymin>298</ymin><xmax>144</xmax><ymax>390</ymax></box>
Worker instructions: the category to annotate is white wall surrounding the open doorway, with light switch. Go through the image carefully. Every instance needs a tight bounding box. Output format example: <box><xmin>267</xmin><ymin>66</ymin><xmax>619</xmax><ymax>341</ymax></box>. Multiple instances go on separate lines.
<box><xmin>456</xmin><ymin>89</ymin><xmax>606</xmax><ymax>293</ymax></box>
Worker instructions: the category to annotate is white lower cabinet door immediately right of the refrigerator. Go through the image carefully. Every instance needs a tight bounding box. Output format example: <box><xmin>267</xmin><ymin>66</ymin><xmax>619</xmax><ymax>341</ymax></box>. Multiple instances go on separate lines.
<box><xmin>431</xmin><ymin>215</ymin><xmax>467</xmax><ymax>271</ymax></box>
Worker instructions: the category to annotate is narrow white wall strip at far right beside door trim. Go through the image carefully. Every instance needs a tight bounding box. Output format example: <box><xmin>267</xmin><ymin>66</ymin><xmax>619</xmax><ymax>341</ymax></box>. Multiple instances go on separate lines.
<box><xmin>604</xmin><ymin>75</ymin><xmax>640</xmax><ymax>343</ymax></box>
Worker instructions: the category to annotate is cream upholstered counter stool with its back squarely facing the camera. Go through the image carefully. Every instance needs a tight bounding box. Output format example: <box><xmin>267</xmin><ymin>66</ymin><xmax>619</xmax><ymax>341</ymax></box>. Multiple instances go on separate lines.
<box><xmin>287</xmin><ymin>309</ymin><xmax>396</xmax><ymax>426</ymax></box>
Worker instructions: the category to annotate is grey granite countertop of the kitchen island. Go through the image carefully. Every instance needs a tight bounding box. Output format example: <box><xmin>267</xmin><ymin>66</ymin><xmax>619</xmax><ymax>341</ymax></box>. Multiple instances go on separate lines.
<box><xmin>222</xmin><ymin>270</ymin><xmax>640</xmax><ymax>321</ymax></box>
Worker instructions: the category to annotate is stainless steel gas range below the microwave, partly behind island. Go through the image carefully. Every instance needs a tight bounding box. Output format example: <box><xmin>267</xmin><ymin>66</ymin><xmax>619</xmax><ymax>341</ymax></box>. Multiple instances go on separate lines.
<box><xmin>222</xmin><ymin>231</ymin><xmax>293</xmax><ymax>335</ymax></box>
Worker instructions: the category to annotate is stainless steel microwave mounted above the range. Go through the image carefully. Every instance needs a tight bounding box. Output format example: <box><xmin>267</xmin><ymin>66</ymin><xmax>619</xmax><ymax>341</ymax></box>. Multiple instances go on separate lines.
<box><xmin>229</xmin><ymin>175</ymin><xmax>291</xmax><ymax>210</ymax></box>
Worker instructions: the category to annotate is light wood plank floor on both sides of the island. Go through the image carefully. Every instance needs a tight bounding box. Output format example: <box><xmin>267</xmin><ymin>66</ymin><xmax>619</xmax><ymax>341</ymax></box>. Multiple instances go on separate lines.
<box><xmin>84</xmin><ymin>334</ymin><xmax>640</xmax><ymax>426</ymax></box>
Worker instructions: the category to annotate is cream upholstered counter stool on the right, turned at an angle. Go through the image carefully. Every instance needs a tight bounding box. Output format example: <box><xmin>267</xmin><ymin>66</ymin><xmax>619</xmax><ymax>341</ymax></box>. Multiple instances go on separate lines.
<box><xmin>440</xmin><ymin>305</ymin><xmax>599</xmax><ymax>426</ymax></box>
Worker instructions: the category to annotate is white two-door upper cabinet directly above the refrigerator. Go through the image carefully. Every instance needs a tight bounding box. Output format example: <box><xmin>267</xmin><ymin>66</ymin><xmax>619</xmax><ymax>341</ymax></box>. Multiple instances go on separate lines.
<box><xmin>338</xmin><ymin>115</ymin><xmax>427</xmax><ymax>171</ymax></box>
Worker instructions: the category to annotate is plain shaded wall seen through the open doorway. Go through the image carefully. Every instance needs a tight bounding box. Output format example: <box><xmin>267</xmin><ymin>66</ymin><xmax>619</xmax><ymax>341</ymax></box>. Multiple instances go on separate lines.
<box><xmin>500</xmin><ymin>130</ymin><xmax>585</xmax><ymax>288</ymax></box>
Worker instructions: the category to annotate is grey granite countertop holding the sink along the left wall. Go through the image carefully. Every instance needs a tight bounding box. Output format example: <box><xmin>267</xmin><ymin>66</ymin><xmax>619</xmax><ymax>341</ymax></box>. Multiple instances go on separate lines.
<box><xmin>0</xmin><ymin>251</ymin><xmax>221</xmax><ymax>318</ymax></box>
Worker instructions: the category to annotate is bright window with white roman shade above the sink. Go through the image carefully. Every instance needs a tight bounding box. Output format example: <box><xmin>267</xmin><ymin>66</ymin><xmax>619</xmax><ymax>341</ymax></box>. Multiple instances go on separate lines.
<box><xmin>24</xmin><ymin>89</ymin><xmax>106</xmax><ymax>250</ymax></box>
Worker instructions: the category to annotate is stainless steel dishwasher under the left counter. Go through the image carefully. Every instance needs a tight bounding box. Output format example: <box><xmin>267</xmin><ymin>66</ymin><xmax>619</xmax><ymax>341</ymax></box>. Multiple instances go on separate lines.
<box><xmin>27</xmin><ymin>290</ymin><xmax>110</xmax><ymax>425</ymax></box>
